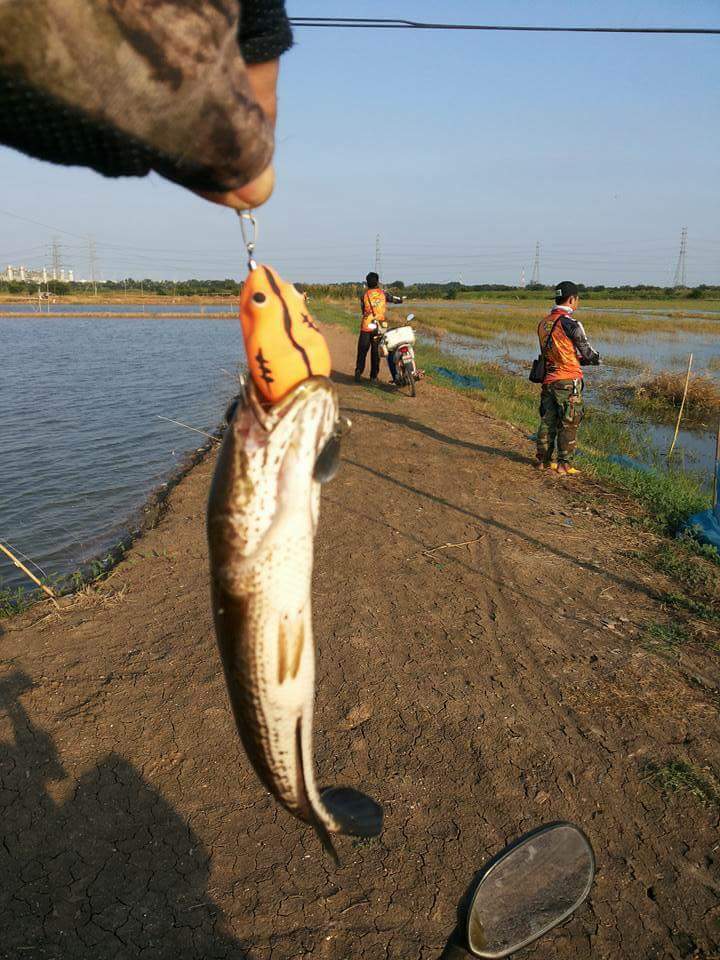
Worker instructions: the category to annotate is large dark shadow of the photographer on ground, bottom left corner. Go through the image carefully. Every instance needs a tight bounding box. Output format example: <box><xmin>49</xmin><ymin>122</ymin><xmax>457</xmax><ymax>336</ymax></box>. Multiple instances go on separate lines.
<box><xmin>0</xmin><ymin>671</ymin><xmax>252</xmax><ymax>960</ymax></box>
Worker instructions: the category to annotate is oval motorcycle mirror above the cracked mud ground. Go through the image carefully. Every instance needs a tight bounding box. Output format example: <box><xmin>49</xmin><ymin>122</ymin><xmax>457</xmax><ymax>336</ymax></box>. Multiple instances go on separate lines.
<box><xmin>467</xmin><ymin>822</ymin><xmax>595</xmax><ymax>960</ymax></box>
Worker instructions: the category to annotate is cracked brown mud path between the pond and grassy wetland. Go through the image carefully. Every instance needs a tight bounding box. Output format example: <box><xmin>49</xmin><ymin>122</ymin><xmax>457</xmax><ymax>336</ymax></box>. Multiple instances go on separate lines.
<box><xmin>0</xmin><ymin>331</ymin><xmax>720</xmax><ymax>960</ymax></box>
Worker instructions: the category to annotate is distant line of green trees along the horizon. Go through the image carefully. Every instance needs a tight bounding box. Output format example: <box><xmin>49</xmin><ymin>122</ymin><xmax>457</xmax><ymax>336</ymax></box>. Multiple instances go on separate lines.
<box><xmin>0</xmin><ymin>277</ymin><xmax>720</xmax><ymax>300</ymax></box>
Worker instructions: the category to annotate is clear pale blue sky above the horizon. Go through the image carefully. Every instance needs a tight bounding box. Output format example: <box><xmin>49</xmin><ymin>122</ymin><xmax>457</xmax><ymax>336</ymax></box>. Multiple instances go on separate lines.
<box><xmin>0</xmin><ymin>0</ymin><xmax>720</xmax><ymax>284</ymax></box>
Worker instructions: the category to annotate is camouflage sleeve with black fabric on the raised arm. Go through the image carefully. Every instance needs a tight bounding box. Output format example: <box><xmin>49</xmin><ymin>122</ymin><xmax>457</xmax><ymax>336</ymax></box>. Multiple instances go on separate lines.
<box><xmin>0</xmin><ymin>0</ymin><xmax>282</xmax><ymax>192</ymax></box>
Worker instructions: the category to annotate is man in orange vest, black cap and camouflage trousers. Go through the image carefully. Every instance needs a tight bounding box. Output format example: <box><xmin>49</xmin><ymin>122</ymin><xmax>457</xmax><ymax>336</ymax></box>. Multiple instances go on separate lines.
<box><xmin>537</xmin><ymin>280</ymin><xmax>600</xmax><ymax>476</ymax></box>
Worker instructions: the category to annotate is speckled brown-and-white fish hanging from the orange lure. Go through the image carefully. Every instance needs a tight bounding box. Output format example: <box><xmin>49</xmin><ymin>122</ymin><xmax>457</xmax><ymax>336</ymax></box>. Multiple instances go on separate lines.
<box><xmin>207</xmin><ymin>264</ymin><xmax>383</xmax><ymax>863</ymax></box>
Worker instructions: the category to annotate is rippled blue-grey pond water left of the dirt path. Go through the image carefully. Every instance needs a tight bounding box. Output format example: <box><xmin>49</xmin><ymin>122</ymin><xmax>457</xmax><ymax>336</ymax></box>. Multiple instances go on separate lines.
<box><xmin>0</xmin><ymin>316</ymin><xmax>243</xmax><ymax>587</ymax></box>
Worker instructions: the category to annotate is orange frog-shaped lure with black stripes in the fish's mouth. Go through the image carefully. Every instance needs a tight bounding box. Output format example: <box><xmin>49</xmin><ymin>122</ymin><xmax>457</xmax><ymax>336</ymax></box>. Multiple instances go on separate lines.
<box><xmin>240</xmin><ymin>264</ymin><xmax>331</xmax><ymax>403</ymax></box>
